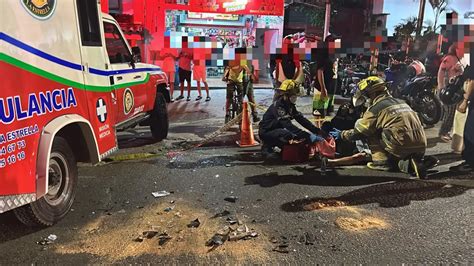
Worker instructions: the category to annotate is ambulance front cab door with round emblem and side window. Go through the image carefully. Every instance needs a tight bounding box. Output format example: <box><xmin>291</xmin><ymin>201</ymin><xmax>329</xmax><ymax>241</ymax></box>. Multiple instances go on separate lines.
<box><xmin>103</xmin><ymin>19</ymin><xmax>148</xmax><ymax>124</ymax></box>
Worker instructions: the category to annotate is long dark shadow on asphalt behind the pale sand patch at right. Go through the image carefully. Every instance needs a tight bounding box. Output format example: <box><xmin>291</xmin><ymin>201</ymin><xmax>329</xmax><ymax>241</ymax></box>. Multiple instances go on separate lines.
<box><xmin>281</xmin><ymin>177</ymin><xmax>469</xmax><ymax>212</ymax></box>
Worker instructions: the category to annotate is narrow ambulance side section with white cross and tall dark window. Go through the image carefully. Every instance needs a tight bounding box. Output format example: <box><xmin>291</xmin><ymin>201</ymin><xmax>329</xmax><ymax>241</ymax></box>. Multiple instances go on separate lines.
<box><xmin>76</xmin><ymin>0</ymin><xmax>117</xmax><ymax>157</ymax></box>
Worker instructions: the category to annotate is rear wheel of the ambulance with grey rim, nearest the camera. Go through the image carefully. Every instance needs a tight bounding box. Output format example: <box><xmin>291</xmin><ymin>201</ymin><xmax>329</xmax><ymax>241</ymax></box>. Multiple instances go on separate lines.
<box><xmin>14</xmin><ymin>137</ymin><xmax>78</xmax><ymax>227</ymax></box>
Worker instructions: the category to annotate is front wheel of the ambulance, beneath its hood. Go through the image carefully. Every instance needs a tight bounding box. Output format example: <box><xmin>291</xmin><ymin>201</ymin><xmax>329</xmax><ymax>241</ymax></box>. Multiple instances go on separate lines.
<box><xmin>150</xmin><ymin>92</ymin><xmax>169</xmax><ymax>141</ymax></box>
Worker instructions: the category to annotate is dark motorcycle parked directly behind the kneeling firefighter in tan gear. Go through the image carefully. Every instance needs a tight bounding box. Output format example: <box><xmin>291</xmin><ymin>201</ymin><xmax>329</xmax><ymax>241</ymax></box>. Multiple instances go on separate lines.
<box><xmin>385</xmin><ymin>63</ymin><xmax>442</xmax><ymax>125</ymax></box>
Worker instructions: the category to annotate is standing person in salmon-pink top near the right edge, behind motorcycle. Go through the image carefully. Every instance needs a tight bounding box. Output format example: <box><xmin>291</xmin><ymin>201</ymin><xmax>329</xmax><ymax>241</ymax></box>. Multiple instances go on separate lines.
<box><xmin>438</xmin><ymin>43</ymin><xmax>464</xmax><ymax>142</ymax></box>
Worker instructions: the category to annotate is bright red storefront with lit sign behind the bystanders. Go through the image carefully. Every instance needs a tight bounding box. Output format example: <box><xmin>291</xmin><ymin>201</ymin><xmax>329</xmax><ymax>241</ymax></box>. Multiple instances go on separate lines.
<box><xmin>101</xmin><ymin>0</ymin><xmax>284</xmax><ymax>76</ymax></box>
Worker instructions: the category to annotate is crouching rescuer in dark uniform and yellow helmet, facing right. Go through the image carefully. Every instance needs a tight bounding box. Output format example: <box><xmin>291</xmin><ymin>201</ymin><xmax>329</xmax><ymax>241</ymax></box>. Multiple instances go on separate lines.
<box><xmin>259</xmin><ymin>80</ymin><xmax>324</xmax><ymax>159</ymax></box>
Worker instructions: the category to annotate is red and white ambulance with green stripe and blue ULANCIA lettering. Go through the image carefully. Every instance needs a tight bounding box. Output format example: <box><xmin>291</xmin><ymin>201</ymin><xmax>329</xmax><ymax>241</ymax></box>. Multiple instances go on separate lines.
<box><xmin>0</xmin><ymin>0</ymin><xmax>170</xmax><ymax>226</ymax></box>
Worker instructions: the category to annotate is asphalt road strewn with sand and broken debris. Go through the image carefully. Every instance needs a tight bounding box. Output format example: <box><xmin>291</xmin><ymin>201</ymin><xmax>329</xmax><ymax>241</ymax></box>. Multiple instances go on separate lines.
<box><xmin>0</xmin><ymin>90</ymin><xmax>474</xmax><ymax>265</ymax></box>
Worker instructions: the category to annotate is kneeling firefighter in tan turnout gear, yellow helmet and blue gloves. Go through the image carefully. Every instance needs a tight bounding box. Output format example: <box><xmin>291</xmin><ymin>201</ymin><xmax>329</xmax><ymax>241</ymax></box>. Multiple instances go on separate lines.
<box><xmin>330</xmin><ymin>76</ymin><xmax>438</xmax><ymax>178</ymax></box>
